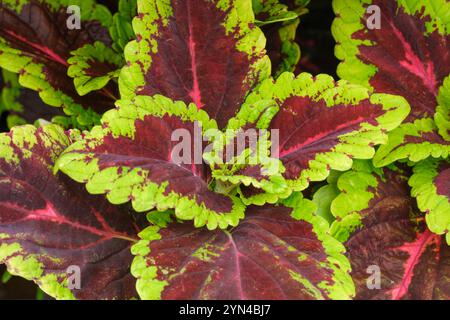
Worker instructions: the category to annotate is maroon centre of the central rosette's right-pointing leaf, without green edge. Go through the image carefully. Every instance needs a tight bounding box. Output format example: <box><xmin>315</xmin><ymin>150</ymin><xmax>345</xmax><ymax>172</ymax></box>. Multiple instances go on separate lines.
<box><xmin>270</xmin><ymin>96</ymin><xmax>384</xmax><ymax>180</ymax></box>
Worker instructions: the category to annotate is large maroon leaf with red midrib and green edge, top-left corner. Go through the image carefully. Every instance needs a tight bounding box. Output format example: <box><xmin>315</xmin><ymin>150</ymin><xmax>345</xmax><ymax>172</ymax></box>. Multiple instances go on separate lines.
<box><xmin>0</xmin><ymin>0</ymin><xmax>115</xmax><ymax>127</ymax></box>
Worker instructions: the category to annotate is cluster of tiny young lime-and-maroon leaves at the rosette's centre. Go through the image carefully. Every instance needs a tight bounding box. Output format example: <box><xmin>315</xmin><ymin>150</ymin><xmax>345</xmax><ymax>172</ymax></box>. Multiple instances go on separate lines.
<box><xmin>203</xmin><ymin>116</ymin><xmax>291</xmax><ymax>205</ymax></box>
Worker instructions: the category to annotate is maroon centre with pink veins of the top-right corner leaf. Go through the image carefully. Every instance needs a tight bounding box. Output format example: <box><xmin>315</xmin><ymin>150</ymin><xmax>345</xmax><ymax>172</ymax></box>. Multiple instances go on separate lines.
<box><xmin>355</xmin><ymin>0</ymin><xmax>450</xmax><ymax>121</ymax></box>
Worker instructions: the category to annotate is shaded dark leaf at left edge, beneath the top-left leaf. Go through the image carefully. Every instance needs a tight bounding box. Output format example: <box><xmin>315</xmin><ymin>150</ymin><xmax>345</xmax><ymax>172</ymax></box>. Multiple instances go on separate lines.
<box><xmin>0</xmin><ymin>69</ymin><xmax>63</xmax><ymax>128</ymax></box>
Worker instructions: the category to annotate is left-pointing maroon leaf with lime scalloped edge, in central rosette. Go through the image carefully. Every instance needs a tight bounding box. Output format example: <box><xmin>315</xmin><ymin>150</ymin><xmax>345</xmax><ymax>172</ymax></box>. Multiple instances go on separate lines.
<box><xmin>56</xmin><ymin>95</ymin><xmax>244</xmax><ymax>229</ymax></box>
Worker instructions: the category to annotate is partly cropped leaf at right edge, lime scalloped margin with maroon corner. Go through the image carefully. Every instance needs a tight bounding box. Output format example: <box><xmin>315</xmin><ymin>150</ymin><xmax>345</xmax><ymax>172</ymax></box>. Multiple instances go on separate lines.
<box><xmin>409</xmin><ymin>159</ymin><xmax>450</xmax><ymax>245</ymax></box>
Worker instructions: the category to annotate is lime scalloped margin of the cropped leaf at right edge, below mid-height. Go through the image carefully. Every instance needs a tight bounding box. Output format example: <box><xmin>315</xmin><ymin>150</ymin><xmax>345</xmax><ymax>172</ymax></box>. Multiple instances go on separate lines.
<box><xmin>408</xmin><ymin>159</ymin><xmax>450</xmax><ymax>245</ymax></box>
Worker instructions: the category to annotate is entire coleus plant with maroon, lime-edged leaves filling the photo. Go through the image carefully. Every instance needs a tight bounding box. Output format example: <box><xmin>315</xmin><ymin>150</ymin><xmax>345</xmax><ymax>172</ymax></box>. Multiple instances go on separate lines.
<box><xmin>0</xmin><ymin>0</ymin><xmax>450</xmax><ymax>299</ymax></box>
